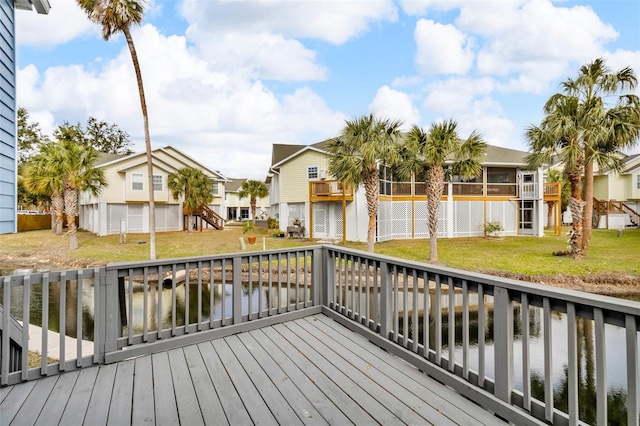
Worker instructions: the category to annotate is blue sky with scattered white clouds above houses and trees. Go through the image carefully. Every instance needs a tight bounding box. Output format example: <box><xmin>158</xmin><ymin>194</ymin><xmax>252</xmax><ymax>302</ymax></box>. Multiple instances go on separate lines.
<box><xmin>16</xmin><ymin>0</ymin><xmax>640</xmax><ymax>179</ymax></box>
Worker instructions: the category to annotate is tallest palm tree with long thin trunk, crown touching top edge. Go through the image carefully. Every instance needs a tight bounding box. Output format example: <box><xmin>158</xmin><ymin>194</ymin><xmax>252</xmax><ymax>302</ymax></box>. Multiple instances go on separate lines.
<box><xmin>76</xmin><ymin>0</ymin><xmax>156</xmax><ymax>260</ymax></box>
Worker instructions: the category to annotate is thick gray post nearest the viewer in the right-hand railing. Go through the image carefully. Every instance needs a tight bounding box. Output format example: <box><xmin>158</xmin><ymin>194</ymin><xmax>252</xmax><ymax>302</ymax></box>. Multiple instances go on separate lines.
<box><xmin>493</xmin><ymin>287</ymin><xmax>513</xmax><ymax>404</ymax></box>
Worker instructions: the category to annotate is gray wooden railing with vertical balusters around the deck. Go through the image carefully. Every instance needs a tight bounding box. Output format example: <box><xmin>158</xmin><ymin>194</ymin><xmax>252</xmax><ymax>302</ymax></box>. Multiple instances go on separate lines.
<box><xmin>0</xmin><ymin>246</ymin><xmax>640</xmax><ymax>424</ymax></box>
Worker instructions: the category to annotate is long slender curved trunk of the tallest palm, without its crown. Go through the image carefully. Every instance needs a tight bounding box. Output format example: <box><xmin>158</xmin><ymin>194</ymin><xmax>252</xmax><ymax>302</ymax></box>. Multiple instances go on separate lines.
<box><xmin>122</xmin><ymin>27</ymin><xmax>156</xmax><ymax>260</ymax></box>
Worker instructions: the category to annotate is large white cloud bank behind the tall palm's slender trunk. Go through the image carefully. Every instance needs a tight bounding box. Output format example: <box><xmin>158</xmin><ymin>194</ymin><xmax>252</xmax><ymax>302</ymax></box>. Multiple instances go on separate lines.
<box><xmin>17</xmin><ymin>25</ymin><xmax>344</xmax><ymax>179</ymax></box>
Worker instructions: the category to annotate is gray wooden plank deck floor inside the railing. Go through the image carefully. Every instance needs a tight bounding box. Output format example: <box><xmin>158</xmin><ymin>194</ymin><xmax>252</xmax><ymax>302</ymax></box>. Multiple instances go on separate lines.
<box><xmin>0</xmin><ymin>315</ymin><xmax>500</xmax><ymax>426</ymax></box>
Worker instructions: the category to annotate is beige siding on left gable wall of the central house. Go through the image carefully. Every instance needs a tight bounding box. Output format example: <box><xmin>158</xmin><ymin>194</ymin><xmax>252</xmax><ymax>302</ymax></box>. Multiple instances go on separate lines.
<box><xmin>280</xmin><ymin>151</ymin><xmax>329</xmax><ymax>203</ymax></box>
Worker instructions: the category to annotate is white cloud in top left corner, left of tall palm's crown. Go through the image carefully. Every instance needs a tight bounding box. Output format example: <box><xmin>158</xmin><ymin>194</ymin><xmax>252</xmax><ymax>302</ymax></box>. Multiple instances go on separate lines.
<box><xmin>16</xmin><ymin>0</ymin><xmax>100</xmax><ymax>47</ymax></box>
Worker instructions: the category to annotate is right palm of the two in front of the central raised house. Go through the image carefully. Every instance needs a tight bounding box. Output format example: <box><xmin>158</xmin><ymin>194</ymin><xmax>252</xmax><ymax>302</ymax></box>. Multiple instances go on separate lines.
<box><xmin>396</xmin><ymin>120</ymin><xmax>487</xmax><ymax>262</ymax></box>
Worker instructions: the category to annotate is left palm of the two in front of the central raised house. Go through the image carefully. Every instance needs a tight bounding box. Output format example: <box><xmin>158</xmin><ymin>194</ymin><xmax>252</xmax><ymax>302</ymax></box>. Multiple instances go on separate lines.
<box><xmin>328</xmin><ymin>114</ymin><xmax>402</xmax><ymax>253</ymax></box>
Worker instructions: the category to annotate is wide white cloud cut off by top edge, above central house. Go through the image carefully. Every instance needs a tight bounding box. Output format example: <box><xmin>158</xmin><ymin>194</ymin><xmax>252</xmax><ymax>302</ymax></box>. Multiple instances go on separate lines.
<box><xmin>180</xmin><ymin>0</ymin><xmax>397</xmax><ymax>44</ymax></box>
